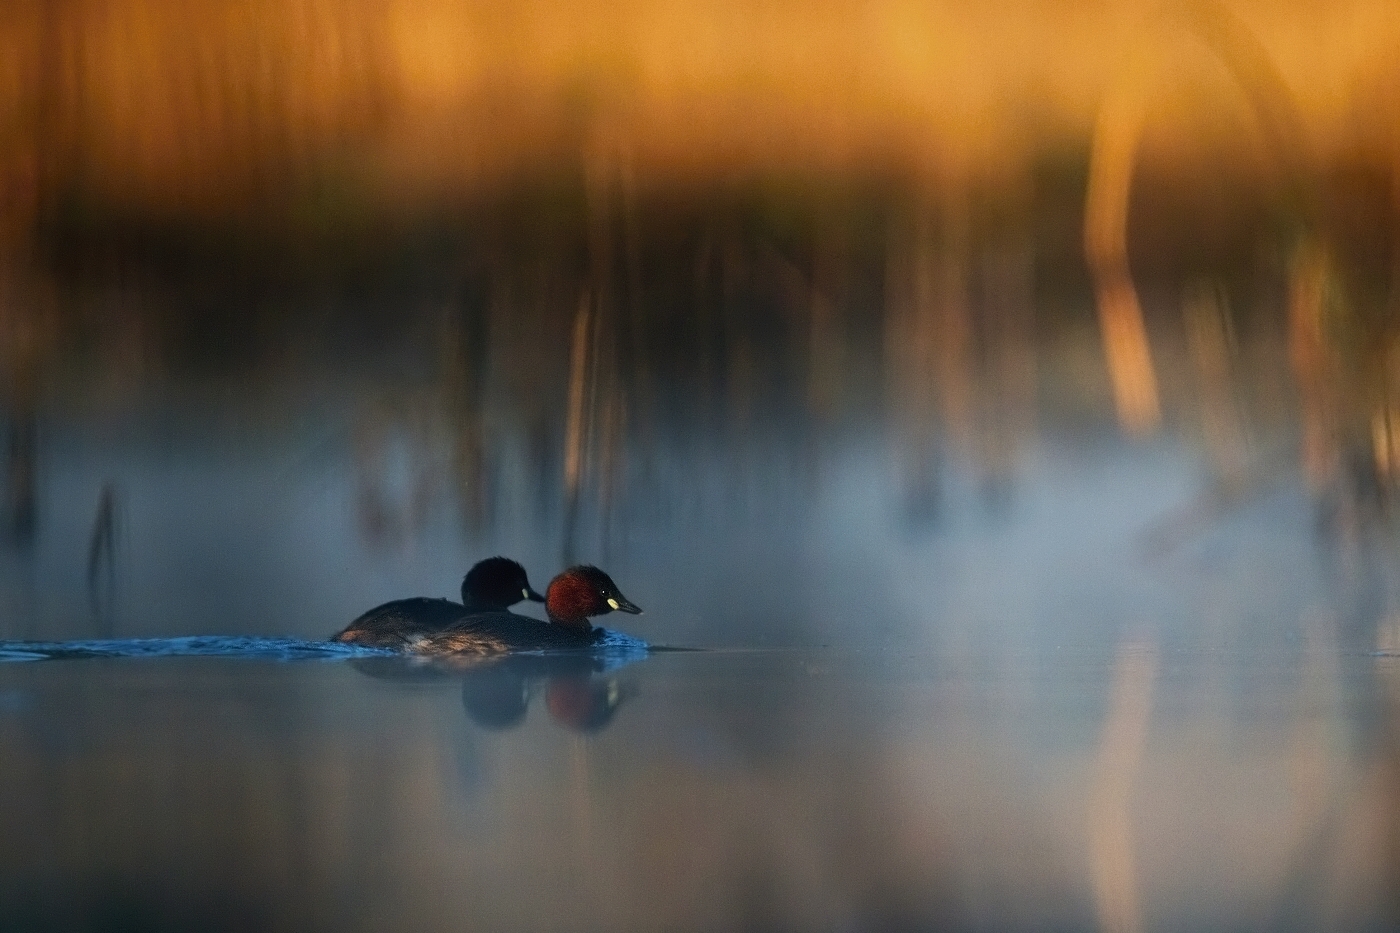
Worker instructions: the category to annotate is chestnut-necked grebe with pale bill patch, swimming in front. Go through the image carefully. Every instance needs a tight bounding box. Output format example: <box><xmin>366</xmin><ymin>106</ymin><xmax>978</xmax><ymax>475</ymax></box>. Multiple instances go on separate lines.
<box><xmin>403</xmin><ymin>566</ymin><xmax>641</xmax><ymax>654</ymax></box>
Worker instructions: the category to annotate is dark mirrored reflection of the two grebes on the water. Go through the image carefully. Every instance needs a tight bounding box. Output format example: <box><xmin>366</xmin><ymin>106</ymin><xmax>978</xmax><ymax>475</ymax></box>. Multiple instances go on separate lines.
<box><xmin>351</xmin><ymin>651</ymin><xmax>645</xmax><ymax>733</ymax></box>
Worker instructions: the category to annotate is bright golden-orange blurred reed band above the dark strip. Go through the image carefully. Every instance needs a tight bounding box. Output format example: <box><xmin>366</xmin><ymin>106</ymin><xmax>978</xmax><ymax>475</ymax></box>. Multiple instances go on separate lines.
<box><xmin>0</xmin><ymin>0</ymin><xmax>1400</xmax><ymax>210</ymax></box>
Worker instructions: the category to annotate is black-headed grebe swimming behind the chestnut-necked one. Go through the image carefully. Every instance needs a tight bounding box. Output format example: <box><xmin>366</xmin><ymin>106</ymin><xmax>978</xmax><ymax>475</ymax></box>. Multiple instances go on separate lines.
<box><xmin>333</xmin><ymin>558</ymin><xmax>545</xmax><ymax>647</ymax></box>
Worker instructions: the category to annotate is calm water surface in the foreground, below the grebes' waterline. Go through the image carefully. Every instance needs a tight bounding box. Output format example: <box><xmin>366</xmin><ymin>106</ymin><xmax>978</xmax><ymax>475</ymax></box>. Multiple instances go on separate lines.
<box><xmin>0</xmin><ymin>632</ymin><xmax>1400</xmax><ymax>930</ymax></box>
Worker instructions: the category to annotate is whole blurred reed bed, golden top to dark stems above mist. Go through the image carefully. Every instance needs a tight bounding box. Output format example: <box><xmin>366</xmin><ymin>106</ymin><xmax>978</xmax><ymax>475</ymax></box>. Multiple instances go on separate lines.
<box><xmin>0</xmin><ymin>0</ymin><xmax>1400</xmax><ymax>636</ymax></box>
